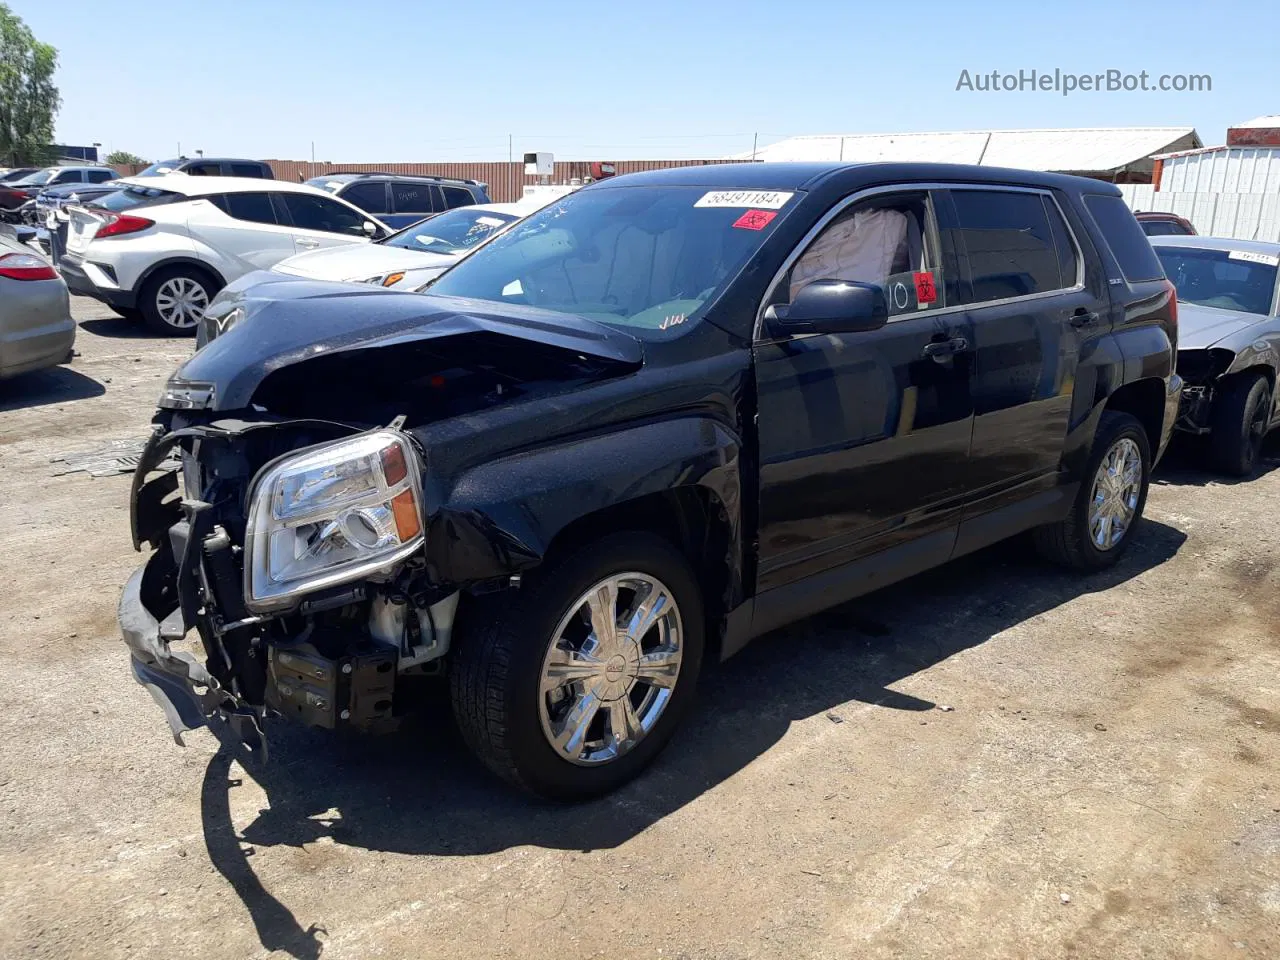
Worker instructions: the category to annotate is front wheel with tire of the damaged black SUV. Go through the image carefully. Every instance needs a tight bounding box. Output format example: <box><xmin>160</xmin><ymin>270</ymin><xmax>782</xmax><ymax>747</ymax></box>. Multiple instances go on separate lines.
<box><xmin>451</xmin><ymin>531</ymin><xmax>704</xmax><ymax>800</ymax></box>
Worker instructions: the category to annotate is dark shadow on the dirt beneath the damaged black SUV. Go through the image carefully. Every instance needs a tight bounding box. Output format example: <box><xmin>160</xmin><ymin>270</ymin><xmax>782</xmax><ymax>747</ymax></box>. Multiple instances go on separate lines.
<box><xmin>201</xmin><ymin>521</ymin><xmax>1185</xmax><ymax>957</ymax></box>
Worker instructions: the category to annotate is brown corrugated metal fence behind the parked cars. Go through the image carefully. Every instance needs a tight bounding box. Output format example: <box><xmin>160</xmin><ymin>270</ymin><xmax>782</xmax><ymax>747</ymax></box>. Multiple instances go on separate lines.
<box><xmin>115</xmin><ymin>160</ymin><xmax>750</xmax><ymax>204</ymax></box>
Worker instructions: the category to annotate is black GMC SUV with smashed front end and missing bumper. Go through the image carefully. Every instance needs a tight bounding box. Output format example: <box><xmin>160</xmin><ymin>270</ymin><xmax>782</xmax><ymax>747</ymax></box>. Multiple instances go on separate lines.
<box><xmin>120</xmin><ymin>164</ymin><xmax>1180</xmax><ymax>799</ymax></box>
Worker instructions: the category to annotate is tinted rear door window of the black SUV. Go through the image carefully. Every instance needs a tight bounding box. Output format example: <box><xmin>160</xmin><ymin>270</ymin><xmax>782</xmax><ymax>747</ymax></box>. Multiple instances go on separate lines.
<box><xmin>951</xmin><ymin>189</ymin><xmax>1075</xmax><ymax>303</ymax></box>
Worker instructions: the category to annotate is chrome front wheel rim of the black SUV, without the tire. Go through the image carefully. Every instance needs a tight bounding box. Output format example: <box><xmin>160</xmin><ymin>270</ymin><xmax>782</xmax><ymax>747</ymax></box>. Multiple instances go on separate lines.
<box><xmin>538</xmin><ymin>572</ymin><xmax>684</xmax><ymax>765</ymax></box>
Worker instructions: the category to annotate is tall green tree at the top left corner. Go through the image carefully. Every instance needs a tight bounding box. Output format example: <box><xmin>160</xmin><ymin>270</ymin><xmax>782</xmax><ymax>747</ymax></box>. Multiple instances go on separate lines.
<box><xmin>0</xmin><ymin>3</ymin><xmax>61</xmax><ymax>166</ymax></box>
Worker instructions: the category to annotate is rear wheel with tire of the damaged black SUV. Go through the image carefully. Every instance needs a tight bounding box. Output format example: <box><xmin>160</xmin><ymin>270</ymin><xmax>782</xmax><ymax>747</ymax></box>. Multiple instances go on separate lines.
<box><xmin>1032</xmin><ymin>410</ymin><xmax>1151</xmax><ymax>572</ymax></box>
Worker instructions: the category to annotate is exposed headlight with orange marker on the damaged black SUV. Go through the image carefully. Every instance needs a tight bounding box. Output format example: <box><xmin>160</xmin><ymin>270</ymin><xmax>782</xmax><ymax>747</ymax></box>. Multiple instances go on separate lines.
<box><xmin>244</xmin><ymin>430</ymin><xmax>422</xmax><ymax>612</ymax></box>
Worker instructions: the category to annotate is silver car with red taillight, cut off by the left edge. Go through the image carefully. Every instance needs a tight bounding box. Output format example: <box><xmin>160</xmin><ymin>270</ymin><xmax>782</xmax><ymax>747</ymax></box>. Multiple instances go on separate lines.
<box><xmin>0</xmin><ymin>228</ymin><xmax>76</xmax><ymax>378</ymax></box>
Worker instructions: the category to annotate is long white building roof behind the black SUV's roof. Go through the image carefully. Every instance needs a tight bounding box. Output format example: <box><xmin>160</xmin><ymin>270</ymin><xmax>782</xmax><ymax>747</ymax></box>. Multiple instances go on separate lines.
<box><xmin>731</xmin><ymin>127</ymin><xmax>1203</xmax><ymax>174</ymax></box>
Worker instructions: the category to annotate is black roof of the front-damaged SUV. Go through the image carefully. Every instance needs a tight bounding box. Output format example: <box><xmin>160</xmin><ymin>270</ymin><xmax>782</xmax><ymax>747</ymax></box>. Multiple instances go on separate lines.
<box><xmin>593</xmin><ymin>163</ymin><xmax>1120</xmax><ymax>196</ymax></box>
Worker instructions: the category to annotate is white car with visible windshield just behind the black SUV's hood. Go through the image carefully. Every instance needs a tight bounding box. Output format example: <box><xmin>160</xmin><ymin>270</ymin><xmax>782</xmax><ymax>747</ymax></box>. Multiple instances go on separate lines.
<box><xmin>273</xmin><ymin>204</ymin><xmax>529</xmax><ymax>289</ymax></box>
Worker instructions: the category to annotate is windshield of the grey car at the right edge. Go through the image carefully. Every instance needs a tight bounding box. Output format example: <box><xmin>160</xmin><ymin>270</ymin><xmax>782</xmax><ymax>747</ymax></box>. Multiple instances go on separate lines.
<box><xmin>1156</xmin><ymin>247</ymin><xmax>1280</xmax><ymax>316</ymax></box>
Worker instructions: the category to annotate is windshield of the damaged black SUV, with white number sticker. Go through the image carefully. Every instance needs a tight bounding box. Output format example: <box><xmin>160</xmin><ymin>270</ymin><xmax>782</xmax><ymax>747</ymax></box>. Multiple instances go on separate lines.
<box><xmin>425</xmin><ymin>186</ymin><xmax>794</xmax><ymax>330</ymax></box>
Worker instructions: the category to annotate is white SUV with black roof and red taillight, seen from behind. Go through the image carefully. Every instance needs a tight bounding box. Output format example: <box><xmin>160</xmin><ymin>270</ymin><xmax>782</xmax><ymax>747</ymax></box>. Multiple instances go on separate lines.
<box><xmin>58</xmin><ymin>174</ymin><xmax>390</xmax><ymax>337</ymax></box>
